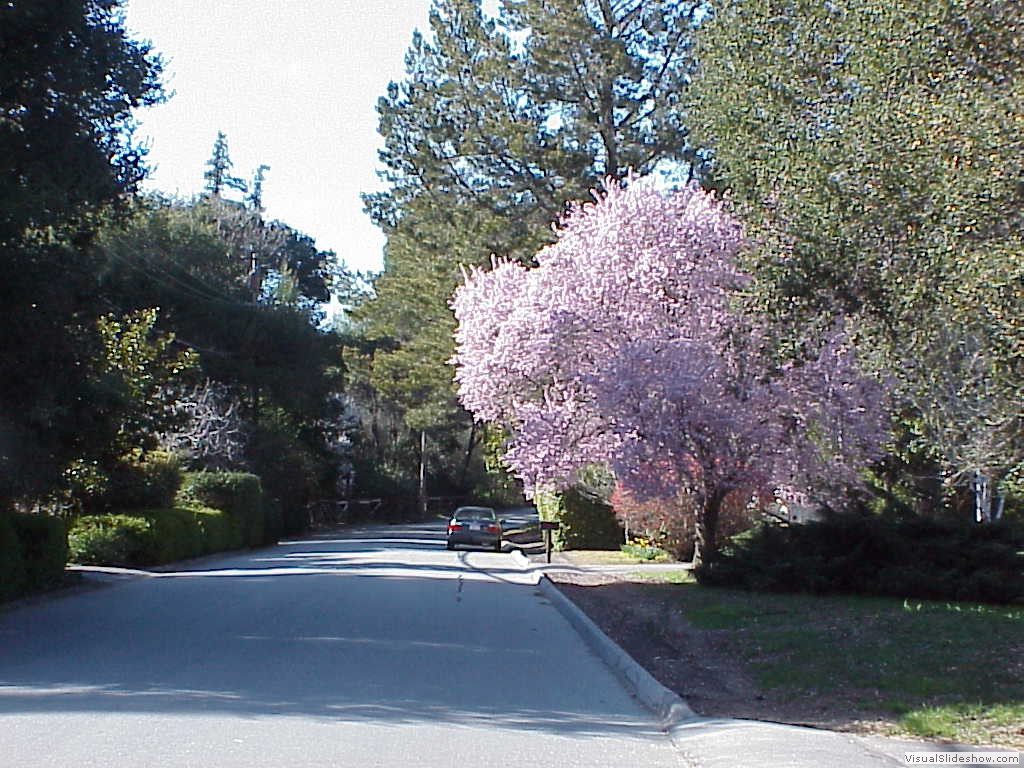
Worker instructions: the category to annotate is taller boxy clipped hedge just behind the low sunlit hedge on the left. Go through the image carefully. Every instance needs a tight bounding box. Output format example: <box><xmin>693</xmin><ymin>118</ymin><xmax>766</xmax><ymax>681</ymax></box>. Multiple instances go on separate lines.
<box><xmin>177</xmin><ymin>472</ymin><xmax>267</xmax><ymax>547</ymax></box>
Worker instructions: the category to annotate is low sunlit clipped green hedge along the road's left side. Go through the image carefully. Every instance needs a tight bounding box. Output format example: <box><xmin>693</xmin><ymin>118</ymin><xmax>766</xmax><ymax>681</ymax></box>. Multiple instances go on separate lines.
<box><xmin>68</xmin><ymin>507</ymin><xmax>241</xmax><ymax>567</ymax></box>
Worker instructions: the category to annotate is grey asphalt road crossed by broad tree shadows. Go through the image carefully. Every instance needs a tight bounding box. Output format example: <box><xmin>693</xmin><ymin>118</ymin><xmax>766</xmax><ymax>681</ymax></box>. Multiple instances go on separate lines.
<box><xmin>0</xmin><ymin>523</ymin><xmax>681</xmax><ymax>768</ymax></box>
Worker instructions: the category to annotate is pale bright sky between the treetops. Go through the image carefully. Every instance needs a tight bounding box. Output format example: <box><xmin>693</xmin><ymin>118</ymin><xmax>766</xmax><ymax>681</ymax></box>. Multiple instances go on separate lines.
<box><xmin>124</xmin><ymin>0</ymin><xmax>430</xmax><ymax>271</ymax></box>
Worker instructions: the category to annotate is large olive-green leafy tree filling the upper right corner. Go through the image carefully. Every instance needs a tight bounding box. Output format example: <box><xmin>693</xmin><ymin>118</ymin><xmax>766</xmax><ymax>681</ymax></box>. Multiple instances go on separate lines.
<box><xmin>690</xmin><ymin>0</ymin><xmax>1024</xmax><ymax>514</ymax></box>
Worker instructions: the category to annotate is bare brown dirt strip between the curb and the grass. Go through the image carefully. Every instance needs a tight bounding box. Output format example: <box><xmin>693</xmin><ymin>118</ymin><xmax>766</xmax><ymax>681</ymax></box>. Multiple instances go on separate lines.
<box><xmin>551</xmin><ymin>573</ymin><xmax>891</xmax><ymax>734</ymax></box>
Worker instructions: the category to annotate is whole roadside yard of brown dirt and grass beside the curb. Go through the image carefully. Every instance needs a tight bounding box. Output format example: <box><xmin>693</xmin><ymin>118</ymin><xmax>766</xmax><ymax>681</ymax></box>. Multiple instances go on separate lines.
<box><xmin>563</xmin><ymin>571</ymin><xmax>1024</xmax><ymax>749</ymax></box>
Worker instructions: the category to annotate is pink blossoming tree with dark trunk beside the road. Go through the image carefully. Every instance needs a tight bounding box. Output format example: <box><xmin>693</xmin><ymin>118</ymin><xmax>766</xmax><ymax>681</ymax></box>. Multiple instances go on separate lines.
<box><xmin>453</xmin><ymin>178</ymin><xmax>885</xmax><ymax>562</ymax></box>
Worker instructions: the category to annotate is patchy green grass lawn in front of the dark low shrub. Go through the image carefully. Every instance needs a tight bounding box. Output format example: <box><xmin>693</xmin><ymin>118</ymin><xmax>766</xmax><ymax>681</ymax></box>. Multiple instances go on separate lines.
<box><xmin>637</xmin><ymin>573</ymin><xmax>1024</xmax><ymax>749</ymax></box>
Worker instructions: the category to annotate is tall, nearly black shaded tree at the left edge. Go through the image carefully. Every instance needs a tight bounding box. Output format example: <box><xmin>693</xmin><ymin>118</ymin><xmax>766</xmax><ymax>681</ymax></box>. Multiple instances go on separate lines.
<box><xmin>0</xmin><ymin>0</ymin><xmax>162</xmax><ymax>503</ymax></box>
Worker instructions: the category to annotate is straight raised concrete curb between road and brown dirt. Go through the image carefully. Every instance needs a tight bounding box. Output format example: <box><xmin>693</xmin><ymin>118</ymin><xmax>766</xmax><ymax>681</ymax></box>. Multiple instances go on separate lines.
<box><xmin>538</xmin><ymin>575</ymin><xmax>697</xmax><ymax>732</ymax></box>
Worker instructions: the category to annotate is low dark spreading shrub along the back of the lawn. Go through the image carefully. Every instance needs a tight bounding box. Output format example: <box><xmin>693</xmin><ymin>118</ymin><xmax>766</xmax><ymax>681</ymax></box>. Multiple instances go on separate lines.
<box><xmin>696</xmin><ymin>514</ymin><xmax>1024</xmax><ymax>603</ymax></box>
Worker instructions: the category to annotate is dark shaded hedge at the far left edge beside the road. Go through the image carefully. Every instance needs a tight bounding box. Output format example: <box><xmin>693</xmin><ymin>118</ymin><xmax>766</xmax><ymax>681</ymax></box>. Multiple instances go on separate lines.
<box><xmin>0</xmin><ymin>513</ymin><xmax>68</xmax><ymax>600</ymax></box>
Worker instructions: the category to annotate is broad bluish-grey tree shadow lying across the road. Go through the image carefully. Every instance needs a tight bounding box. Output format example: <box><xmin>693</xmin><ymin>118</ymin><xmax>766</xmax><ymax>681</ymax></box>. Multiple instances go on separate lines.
<box><xmin>0</xmin><ymin>523</ymin><xmax>655</xmax><ymax>736</ymax></box>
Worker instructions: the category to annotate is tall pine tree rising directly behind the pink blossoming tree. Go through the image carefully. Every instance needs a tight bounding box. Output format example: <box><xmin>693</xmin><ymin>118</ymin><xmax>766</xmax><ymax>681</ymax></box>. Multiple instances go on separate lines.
<box><xmin>358</xmin><ymin>0</ymin><xmax>698</xmax><ymax>495</ymax></box>
